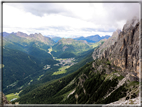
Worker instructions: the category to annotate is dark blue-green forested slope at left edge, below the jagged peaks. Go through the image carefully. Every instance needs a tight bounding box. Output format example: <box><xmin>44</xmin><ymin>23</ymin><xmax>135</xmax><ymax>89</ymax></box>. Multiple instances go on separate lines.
<box><xmin>3</xmin><ymin>48</ymin><xmax>42</xmax><ymax>93</ymax></box>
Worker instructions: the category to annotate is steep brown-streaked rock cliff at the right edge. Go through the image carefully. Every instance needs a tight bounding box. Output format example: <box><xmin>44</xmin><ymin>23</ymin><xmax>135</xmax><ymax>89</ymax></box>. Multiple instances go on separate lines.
<box><xmin>101</xmin><ymin>18</ymin><xmax>140</xmax><ymax>81</ymax></box>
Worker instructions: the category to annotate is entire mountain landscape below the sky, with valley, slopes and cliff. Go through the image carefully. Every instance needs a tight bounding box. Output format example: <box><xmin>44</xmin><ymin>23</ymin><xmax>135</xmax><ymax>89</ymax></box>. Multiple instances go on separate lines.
<box><xmin>1</xmin><ymin>18</ymin><xmax>140</xmax><ymax>105</ymax></box>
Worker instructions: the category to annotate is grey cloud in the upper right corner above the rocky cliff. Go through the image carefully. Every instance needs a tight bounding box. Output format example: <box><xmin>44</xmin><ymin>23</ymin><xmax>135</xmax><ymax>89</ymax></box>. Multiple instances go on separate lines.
<box><xmin>104</xmin><ymin>3</ymin><xmax>140</xmax><ymax>21</ymax></box>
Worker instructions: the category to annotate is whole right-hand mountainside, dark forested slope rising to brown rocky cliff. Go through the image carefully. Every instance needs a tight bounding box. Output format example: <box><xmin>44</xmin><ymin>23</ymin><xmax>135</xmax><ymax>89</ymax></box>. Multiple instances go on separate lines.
<box><xmin>13</xmin><ymin>17</ymin><xmax>140</xmax><ymax>104</ymax></box>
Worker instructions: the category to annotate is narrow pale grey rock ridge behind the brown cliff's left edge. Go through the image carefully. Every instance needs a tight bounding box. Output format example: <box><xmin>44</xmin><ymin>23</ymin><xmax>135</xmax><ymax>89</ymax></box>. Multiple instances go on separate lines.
<box><xmin>92</xmin><ymin>29</ymin><xmax>121</xmax><ymax>60</ymax></box>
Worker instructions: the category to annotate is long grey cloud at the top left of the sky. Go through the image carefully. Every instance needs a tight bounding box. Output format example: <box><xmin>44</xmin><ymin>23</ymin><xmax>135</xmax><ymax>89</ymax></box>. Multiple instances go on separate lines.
<box><xmin>6</xmin><ymin>3</ymin><xmax>71</xmax><ymax>16</ymax></box>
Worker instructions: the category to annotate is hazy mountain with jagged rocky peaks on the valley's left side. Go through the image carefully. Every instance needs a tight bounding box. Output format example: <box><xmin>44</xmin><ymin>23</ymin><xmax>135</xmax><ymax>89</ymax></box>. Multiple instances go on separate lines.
<box><xmin>3</xmin><ymin>32</ymin><xmax>54</xmax><ymax>62</ymax></box>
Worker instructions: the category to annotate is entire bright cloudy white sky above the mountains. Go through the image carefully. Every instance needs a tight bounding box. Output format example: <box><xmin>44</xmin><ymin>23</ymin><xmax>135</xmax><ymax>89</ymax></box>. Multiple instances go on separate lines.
<box><xmin>3</xmin><ymin>3</ymin><xmax>140</xmax><ymax>38</ymax></box>
